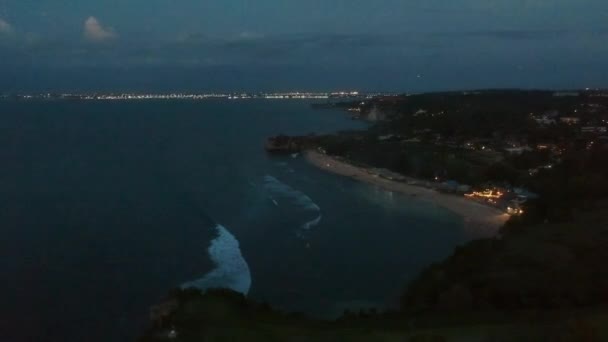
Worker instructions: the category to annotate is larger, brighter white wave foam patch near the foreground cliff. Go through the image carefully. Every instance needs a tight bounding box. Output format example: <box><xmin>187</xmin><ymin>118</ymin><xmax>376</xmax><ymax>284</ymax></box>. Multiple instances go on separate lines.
<box><xmin>182</xmin><ymin>225</ymin><xmax>251</xmax><ymax>295</ymax></box>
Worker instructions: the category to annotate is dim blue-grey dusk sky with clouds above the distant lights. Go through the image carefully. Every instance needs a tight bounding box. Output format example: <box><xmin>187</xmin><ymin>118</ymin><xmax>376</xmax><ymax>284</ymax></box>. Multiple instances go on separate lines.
<box><xmin>0</xmin><ymin>0</ymin><xmax>608</xmax><ymax>92</ymax></box>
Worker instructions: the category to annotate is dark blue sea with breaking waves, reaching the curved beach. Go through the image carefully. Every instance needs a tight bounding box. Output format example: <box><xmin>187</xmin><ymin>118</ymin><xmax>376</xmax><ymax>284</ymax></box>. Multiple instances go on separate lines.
<box><xmin>0</xmin><ymin>100</ymin><xmax>483</xmax><ymax>342</ymax></box>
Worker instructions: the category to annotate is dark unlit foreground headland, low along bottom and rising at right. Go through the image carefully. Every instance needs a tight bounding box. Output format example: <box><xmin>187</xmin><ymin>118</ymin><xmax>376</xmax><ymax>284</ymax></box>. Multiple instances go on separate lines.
<box><xmin>141</xmin><ymin>203</ymin><xmax>608</xmax><ymax>342</ymax></box>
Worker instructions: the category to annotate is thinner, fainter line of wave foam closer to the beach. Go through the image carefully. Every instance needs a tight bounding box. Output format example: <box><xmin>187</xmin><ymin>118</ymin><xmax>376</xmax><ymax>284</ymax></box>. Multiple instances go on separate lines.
<box><xmin>264</xmin><ymin>175</ymin><xmax>323</xmax><ymax>237</ymax></box>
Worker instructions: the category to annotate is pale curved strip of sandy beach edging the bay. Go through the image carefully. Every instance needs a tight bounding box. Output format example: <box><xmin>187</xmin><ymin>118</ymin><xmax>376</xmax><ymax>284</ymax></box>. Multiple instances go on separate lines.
<box><xmin>305</xmin><ymin>150</ymin><xmax>509</xmax><ymax>237</ymax></box>
